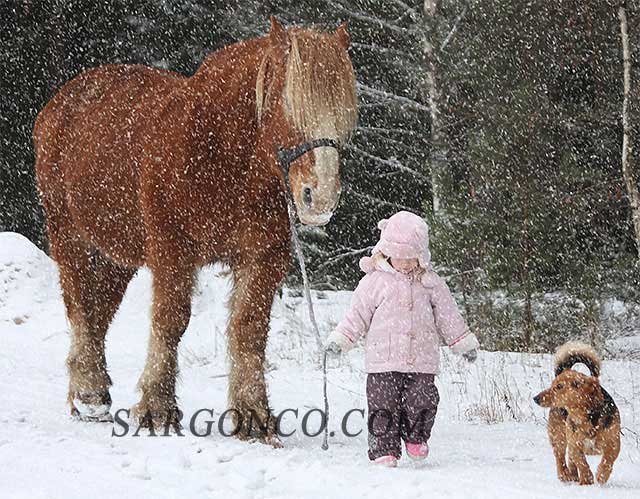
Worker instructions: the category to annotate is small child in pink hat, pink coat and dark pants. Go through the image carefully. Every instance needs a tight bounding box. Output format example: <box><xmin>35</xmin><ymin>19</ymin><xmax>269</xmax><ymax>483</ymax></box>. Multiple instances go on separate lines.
<box><xmin>325</xmin><ymin>211</ymin><xmax>479</xmax><ymax>466</ymax></box>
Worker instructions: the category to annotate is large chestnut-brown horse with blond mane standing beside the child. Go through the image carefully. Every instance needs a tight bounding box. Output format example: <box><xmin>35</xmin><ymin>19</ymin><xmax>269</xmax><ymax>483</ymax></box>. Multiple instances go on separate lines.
<box><xmin>33</xmin><ymin>18</ymin><xmax>357</xmax><ymax>442</ymax></box>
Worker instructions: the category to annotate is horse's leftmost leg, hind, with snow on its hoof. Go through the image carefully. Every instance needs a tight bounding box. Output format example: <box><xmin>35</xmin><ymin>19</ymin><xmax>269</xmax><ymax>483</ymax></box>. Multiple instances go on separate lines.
<box><xmin>50</xmin><ymin>231</ymin><xmax>135</xmax><ymax>420</ymax></box>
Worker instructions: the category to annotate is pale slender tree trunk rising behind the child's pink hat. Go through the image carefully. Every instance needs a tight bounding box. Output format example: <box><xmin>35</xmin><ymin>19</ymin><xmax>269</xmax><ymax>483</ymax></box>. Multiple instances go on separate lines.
<box><xmin>424</xmin><ymin>0</ymin><xmax>448</xmax><ymax>216</ymax></box>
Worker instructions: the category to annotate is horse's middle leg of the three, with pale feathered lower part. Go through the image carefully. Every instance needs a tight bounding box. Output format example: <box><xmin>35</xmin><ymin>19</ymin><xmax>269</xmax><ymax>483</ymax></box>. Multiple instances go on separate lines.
<box><xmin>132</xmin><ymin>247</ymin><xmax>195</xmax><ymax>434</ymax></box>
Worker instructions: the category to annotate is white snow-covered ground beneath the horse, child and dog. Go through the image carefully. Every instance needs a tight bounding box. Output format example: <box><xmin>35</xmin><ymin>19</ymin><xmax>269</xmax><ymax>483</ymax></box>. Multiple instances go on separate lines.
<box><xmin>0</xmin><ymin>233</ymin><xmax>640</xmax><ymax>499</ymax></box>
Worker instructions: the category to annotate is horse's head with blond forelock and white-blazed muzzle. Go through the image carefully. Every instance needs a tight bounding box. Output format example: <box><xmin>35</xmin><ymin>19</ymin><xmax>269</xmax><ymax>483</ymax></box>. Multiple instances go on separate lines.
<box><xmin>256</xmin><ymin>17</ymin><xmax>357</xmax><ymax>225</ymax></box>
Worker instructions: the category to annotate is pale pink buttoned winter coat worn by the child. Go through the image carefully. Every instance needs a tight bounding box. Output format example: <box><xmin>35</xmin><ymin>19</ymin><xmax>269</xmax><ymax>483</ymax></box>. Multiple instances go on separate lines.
<box><xmin>328</xmin><ymin>258</ymin><xmax>479</xmax><ymax>374</ymax></box>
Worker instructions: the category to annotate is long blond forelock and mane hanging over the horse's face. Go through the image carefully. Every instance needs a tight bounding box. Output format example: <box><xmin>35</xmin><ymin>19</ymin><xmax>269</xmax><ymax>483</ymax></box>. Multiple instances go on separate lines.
<box><xmin>256</xmin><ymin>28</ymin><xmax>358</xmax><ymax>141</ymax></box>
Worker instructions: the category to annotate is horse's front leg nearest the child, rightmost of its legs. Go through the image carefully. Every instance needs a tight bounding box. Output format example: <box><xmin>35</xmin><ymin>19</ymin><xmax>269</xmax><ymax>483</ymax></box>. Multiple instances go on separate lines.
<box><xmin>227</xmin><ymin>255</ymin><xmax>288</xmax><ymax>446</ymax></box>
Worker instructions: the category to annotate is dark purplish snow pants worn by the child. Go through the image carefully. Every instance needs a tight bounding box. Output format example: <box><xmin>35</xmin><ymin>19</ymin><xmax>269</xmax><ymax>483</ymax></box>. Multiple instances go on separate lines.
<box><xmin>367</xmin><ymin>371</ymin><xmax>440</xmax><ymax>460</ymax></box>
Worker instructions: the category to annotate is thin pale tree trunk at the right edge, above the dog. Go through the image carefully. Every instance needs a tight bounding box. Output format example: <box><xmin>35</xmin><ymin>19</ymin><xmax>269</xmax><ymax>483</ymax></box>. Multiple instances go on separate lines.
<box><xmin>618</xmin><ymin>2</ymin><xmax>640</xmax><ymax>258</ymax></box>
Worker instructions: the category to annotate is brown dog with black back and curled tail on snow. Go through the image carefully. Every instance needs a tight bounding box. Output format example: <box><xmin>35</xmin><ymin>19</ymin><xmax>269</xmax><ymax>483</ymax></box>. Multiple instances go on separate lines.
<box><xmin>533</xmin><ymin>342</ymin><xmax>620</xmax><ymax>485</ymax></box>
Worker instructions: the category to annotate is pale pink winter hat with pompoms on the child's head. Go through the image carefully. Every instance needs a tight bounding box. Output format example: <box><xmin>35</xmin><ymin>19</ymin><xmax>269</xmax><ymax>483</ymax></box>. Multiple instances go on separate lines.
<box><xmin>360</xmin><ymin>211</ymin><xmax>431</xmax><ymax>272</ymax></box>
